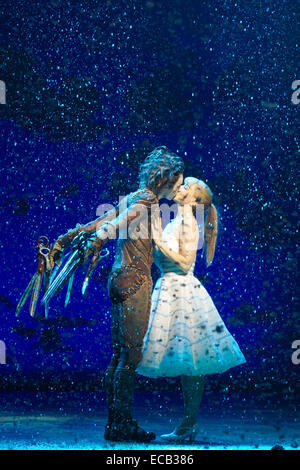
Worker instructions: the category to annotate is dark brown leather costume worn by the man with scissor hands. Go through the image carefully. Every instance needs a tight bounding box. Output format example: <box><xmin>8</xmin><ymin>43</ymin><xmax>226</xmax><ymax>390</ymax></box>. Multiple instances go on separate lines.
<box><xmin>55</xmin><ymin>189</ymin><xmax>159</xmax><ymax>424</ymax></box>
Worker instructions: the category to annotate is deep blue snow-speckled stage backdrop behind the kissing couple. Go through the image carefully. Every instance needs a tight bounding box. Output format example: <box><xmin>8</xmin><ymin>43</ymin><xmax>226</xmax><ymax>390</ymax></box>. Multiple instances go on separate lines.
<box><xmin>0</xmin><ymin>0</ymin><xmax>300</xmax><ymax>400</ymax></box>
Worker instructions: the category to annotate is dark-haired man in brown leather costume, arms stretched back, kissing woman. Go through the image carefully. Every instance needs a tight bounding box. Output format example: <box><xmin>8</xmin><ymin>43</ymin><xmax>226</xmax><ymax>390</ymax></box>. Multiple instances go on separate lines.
<box><xmin>51</xmin><ymin>146</ymin><xmax>184</xmax><ymax>442</ymax></box>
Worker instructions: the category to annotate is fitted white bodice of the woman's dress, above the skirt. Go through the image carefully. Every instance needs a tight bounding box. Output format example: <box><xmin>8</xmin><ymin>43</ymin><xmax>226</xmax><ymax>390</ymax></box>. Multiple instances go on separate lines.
<box><xmin>154</xmin><ymin>215</ymin><xmax>197</xmax><ymax>275</ymax></box>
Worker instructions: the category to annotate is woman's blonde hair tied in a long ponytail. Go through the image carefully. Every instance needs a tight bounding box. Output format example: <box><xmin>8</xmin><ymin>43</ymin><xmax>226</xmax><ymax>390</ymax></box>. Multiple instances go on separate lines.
<box><xmin>184</xmin><ymin>177</ymin><xmax>218</xmax><ymax>266</ymax></box>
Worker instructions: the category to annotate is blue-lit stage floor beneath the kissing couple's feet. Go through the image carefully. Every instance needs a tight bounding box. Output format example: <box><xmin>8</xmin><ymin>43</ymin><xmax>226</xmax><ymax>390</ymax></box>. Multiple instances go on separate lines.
<box><xmin>0</xmin><ymin>392</ymin><xmax>300</xmax><ymax>450</ymax></box>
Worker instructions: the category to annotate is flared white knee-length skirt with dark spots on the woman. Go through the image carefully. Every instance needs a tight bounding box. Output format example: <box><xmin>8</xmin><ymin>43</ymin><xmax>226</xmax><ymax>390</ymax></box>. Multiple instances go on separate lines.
<box><xmin>137</xmin><ymin>273</ymin><xmax>246</xmax><ymax>377</ymax></box>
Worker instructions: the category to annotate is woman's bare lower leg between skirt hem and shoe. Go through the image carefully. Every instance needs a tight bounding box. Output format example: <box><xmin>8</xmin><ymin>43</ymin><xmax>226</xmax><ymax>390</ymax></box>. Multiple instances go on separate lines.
<box><xmin>177</xmin><ymin>375</ymin><xmax>205</xmax><ymax>431</ymax></box>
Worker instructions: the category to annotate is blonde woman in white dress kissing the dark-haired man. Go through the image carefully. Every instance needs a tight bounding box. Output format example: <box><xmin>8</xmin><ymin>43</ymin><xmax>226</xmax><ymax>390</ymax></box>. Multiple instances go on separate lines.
<box><xmin>137</xmin><ymin>177</ymin><xmax>246</xmax><ymax>441</ymax></box>
